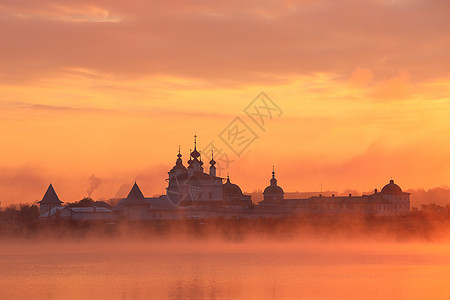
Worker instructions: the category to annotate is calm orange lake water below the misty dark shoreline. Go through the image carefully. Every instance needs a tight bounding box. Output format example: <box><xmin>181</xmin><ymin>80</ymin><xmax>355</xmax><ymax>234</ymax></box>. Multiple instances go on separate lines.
<box><xmin>0</xmin><ymin>241</ymin><xmax>450</xmax><ymax>299</ymax></box>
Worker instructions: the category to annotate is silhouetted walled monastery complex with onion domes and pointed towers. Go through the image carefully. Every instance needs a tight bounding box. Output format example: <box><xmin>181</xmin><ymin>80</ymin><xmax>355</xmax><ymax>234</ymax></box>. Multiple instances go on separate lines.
<box><xmin>39</xmin><ymin>139</ymin><xmax>410</xmax><ymax>221</ymax></box>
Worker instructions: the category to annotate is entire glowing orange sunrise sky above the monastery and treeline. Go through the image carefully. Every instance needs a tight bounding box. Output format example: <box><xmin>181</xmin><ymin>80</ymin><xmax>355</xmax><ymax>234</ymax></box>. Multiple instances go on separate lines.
<box><xmin>0</xmin><ymin>0</ymin><xmax>450</xmax><ymax>205</ymax></box>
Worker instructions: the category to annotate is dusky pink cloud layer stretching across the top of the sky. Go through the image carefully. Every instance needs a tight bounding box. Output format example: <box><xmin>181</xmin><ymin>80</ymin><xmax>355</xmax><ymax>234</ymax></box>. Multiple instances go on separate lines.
<box><xmin>0</xmin><ymin>0</ymin><xmax>450</xmax><ymax>83</ymax></box>
